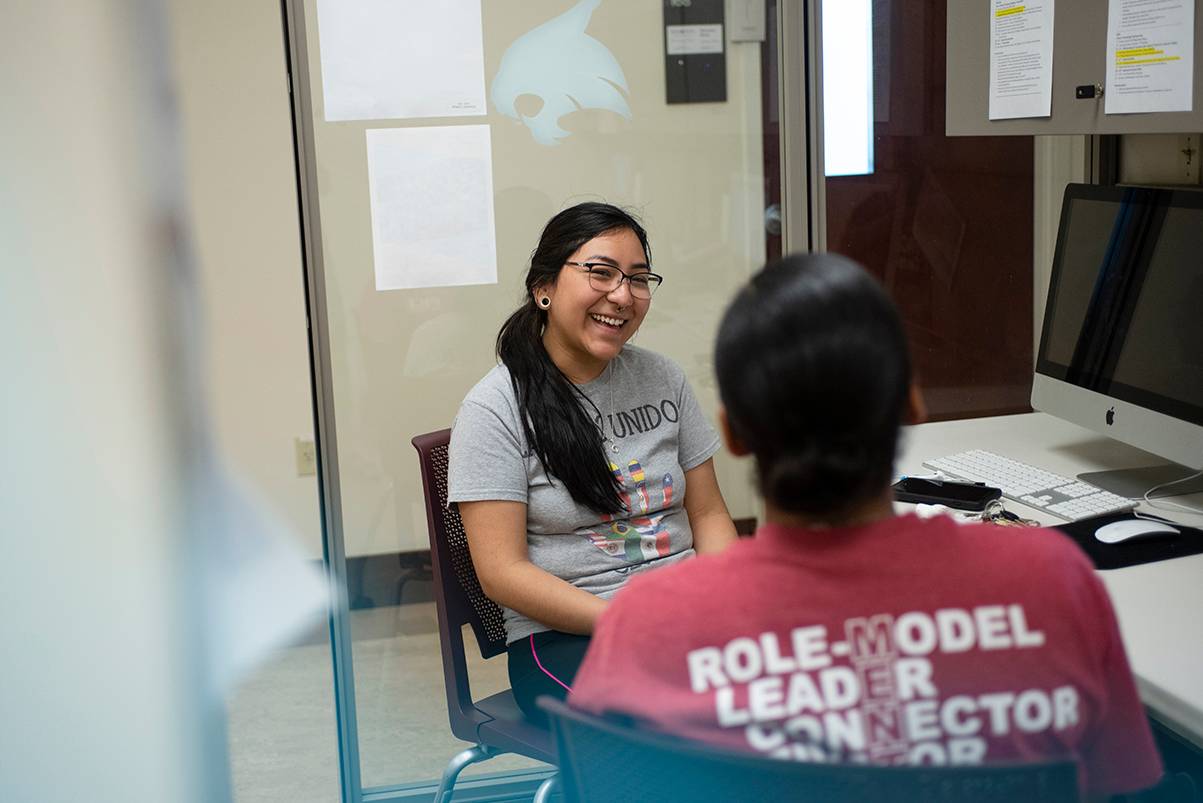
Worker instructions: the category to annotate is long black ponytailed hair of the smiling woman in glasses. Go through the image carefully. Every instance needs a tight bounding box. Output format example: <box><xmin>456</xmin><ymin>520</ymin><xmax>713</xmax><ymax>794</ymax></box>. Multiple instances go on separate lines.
<box><xmin>497</xmin><ymin>202</ymin><xmax>651</xmax><ymax>513</ymax></box>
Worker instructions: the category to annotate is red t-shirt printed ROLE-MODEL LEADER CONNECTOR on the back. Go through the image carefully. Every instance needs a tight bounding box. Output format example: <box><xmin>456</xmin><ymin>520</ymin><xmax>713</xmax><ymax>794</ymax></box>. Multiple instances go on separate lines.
<box><xmin>569</xmin><ymin>516</ymin><xmax>1162</xmax><ymax>793</ymax></box>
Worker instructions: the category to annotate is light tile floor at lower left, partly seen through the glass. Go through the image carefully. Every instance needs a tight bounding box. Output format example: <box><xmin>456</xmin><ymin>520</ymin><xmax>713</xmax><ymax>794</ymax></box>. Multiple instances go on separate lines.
<box><xmin>227</xmin><ymin>603</ymin><xmax>541</xmax><ymax>803</ymax></box>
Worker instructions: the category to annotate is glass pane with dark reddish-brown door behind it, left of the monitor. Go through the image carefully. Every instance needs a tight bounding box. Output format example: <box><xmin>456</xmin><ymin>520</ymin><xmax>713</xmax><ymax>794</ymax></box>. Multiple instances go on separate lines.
<box><xmin>817</xmin><ymin>0</ymin><xmax>1035</xmax><ymax>419</ymax></box>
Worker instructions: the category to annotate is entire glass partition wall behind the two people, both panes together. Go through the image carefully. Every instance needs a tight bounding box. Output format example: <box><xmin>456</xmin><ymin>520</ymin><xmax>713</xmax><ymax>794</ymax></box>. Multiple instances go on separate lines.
<box><xmin>285</xmin><ymin>0</ymin><xmax>1033</xmax><ymax>801</ymax></box>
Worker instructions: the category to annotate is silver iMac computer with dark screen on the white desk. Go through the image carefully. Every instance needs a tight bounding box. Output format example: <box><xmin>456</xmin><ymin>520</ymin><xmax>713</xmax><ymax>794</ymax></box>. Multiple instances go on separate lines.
<box><xmin>1032</xmin><ymin>184</ymin><xmax>1203</xmax><ymax>497</ymax></box>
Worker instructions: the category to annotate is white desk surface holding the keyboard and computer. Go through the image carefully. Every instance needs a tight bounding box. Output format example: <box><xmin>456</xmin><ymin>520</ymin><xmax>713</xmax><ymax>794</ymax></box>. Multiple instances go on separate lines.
<box><xmin>897</xmin><ymin>413</ymin><xmax>1203</xmax><ymax>748</ymax></box>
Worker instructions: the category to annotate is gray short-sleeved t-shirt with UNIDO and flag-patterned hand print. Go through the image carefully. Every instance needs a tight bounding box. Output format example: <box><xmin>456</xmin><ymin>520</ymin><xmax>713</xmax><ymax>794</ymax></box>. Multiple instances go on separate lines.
<box><xmin>448</xmin><ymin>346</ymin><xmax>719</xmax><ymax>643</ymax></box>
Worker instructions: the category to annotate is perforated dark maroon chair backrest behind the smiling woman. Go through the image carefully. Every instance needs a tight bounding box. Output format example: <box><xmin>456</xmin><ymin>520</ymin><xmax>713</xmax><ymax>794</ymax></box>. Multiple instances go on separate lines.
<box><xmin>411</xmin><ymin>430</ymin><xmax>505</xmax><ymax>734</ymax></box>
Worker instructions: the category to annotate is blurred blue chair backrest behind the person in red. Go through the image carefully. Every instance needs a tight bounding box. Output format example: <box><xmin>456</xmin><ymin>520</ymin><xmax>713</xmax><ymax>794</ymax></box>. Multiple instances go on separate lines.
<box><xmin>539</xmin><ymin>697</ymin><xmax>1078</xmax><ymax>803</ymax></box>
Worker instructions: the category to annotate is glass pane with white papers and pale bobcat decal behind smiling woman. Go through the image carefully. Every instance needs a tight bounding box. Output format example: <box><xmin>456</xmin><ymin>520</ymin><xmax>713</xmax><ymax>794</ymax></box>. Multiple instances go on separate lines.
<box><xmin>286</xmin><ymin>0</ymin><xmax>778</xmax><ymax>799</ymax></box>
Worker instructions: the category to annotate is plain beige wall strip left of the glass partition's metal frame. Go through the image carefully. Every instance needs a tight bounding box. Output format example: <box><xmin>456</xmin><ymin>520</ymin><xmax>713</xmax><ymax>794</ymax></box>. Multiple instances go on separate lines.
<box><xmin>168</xmin><ymin>0</ymin><xmax>321</xmax><ymax>559</ymax></box>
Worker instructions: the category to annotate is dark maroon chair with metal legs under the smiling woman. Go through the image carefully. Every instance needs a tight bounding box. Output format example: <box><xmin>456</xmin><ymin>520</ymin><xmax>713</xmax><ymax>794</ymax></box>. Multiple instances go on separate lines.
<box><xmin>411</xmin><ymin>430</ymin><xmax>556</xmax><ymax>803</ymax></box>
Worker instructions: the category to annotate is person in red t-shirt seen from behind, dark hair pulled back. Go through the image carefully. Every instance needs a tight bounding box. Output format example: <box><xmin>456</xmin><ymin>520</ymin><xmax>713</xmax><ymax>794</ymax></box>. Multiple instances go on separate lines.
<box><xmin>569</xmin><ymin>254</ymin><xmax>1162</xmax><ymax>797</ymax></box>
